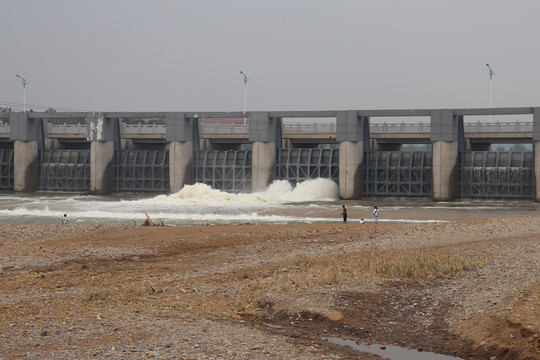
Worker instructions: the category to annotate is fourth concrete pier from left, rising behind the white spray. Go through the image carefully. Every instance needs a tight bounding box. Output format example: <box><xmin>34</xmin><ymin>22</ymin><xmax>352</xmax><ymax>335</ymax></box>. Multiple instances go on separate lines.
<box><xmin>249</xmin><ymin>111</ymin><xmax>281</xmax><ymax>192</ymax></box>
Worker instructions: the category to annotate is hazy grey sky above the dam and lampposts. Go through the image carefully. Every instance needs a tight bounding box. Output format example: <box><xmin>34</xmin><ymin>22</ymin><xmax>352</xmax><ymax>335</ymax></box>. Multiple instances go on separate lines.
<box><xmin>0</xmin><ymin>0</ymin><xmax>540</xmax><ymax>111</ymax></box>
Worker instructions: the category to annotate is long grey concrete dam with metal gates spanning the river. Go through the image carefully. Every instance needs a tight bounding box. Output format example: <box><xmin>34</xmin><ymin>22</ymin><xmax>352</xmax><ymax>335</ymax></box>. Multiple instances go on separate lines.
<box><xmin>0</xmin><ymin>107</ymin><xmax>540</xmax><ymax>201</ymax></box>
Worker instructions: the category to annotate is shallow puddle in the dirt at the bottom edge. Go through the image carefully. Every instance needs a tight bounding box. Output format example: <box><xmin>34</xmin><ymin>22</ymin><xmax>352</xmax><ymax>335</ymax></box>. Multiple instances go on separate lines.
<box><xmin>321</xmin><ymin>337</ymin><xmax>463</xmax><ymax>360</ymax></box>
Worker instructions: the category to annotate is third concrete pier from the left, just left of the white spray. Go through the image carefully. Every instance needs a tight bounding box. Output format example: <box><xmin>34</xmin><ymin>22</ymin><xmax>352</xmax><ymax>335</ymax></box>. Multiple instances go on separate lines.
<box><xmin>169</xmin><ymin>112</ymin><xmax>199</xmax><ymax>193</ymax></box>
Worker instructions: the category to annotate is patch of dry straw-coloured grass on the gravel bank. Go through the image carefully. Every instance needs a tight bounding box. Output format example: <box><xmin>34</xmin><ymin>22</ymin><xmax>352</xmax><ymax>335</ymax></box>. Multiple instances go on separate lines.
<box><xmin>224</xmin><ymin>250</ymin><xmax>489</xmax><ymax>314</ymax></box>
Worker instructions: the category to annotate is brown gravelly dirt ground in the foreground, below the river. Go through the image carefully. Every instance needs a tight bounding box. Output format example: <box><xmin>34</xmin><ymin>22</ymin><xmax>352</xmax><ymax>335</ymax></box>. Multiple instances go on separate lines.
<box><xmin>0</xmin><ymin>221</ymin><xmax>540</xmax><ymax>360</ymax></box>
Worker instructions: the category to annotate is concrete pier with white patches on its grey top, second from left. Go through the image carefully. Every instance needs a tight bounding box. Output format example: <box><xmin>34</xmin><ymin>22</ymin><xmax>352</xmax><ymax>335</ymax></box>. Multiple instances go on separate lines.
<box><xmin>86</xmin><ymin>113</ymin><xmax>117</xmax><ymax>194</ymax></box>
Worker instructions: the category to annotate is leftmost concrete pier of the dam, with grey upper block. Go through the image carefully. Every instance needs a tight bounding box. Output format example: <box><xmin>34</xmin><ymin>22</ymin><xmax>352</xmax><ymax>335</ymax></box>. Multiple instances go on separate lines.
<box><xmin>10</xmin><ymin>112</ymin><xmax>43</xmax><ymax>192</ymax></box>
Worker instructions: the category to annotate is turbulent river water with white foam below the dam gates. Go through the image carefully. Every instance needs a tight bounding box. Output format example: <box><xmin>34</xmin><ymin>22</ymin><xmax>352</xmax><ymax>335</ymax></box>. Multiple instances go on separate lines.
<box><xmin>0</xmin><ymin>179</ymin><xmax>540</xmax><ymax>225</ymax></box>
